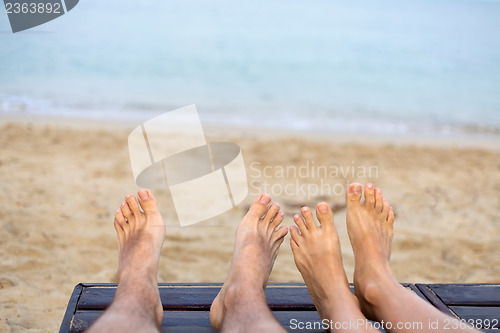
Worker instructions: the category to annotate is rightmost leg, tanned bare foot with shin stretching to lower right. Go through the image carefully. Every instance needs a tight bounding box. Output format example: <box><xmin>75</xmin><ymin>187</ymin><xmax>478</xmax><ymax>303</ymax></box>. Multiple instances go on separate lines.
<box><xmin>346</xmin><ymin>183</ymin><xmax>478</xmax><ymax>333</ymax></box>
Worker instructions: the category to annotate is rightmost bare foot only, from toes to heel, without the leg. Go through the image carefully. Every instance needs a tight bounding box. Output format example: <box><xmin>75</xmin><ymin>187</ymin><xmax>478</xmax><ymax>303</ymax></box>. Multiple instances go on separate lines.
<box><xmin>346</xmin><ymin>183</ymin><xmax>398</xmax><ymax>318</ymax></box>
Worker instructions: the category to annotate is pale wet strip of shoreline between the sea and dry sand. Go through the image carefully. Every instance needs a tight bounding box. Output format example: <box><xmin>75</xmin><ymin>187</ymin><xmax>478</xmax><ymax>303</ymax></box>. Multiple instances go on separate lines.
<box><xmin>0</xmin><ymin>115</ymin><xmax>500</xmax><ymax>151</ymax></box>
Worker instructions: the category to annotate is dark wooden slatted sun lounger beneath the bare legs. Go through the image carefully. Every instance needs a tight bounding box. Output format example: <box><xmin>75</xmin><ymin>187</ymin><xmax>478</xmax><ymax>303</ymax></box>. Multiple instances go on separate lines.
<box><xmin>60</xmin><ymin>283</ymin><xmax>500</xmax><ymax>333</ymax></box>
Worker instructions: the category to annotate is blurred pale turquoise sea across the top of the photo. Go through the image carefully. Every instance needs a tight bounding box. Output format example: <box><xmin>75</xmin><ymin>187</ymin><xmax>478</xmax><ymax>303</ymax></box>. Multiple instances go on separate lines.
<box><xmin>0</xmin><ymin>0</ymin><xmax>500</xmax><ymax>134</ymax></box>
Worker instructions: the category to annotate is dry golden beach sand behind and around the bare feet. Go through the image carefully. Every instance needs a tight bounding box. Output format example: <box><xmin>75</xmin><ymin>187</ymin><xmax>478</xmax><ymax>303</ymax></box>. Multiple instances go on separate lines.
<box><xmin>0</xmin><ymin>119</ymin><xmax>500</xmax><ymax>332</ymax></box>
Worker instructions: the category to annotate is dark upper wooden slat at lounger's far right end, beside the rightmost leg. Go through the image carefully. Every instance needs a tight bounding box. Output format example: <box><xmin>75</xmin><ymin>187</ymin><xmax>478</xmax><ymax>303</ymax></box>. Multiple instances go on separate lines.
<box><xmin>429</xmin><ymin>284</ymin><xmax>500</xmax><ymax>306</ymax></box>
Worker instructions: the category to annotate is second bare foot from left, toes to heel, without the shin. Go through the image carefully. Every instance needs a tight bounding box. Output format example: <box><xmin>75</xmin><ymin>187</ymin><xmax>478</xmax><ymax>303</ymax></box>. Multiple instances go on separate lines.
<box><xmin>210</xmin><ymin>194</ymin><xmax>288</xmax><ymax>329</ymax></box>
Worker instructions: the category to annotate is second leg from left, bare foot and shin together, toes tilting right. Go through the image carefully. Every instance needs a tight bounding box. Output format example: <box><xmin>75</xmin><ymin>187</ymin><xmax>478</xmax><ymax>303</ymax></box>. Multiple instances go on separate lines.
<box><xmin>210</xmin><ymin>194</ymin><xmax>288</xmax><ymax>332</ymax></box>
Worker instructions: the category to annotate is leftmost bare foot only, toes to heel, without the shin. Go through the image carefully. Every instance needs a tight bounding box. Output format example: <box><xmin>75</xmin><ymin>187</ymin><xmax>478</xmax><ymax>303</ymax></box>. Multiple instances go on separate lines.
<box><xmin>114</xmin><ymin>190</ymin><xmax>165</xmax><ymax>325</ymax></box>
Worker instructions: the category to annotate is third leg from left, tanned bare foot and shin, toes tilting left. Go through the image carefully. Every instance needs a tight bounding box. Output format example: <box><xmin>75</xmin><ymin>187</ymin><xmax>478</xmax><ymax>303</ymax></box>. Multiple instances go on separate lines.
<box><xmin>290</xmin><ymin>202</ymin><xmax>378</xmax><ymax>332</ymax></box>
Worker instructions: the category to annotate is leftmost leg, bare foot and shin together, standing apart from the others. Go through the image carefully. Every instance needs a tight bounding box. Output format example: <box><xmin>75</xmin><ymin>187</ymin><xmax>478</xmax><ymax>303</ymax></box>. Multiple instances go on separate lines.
<box><xmin>89</xmin><ymin>190</ymin><xmax>165</xmax><ymax>333</ymax></box>
